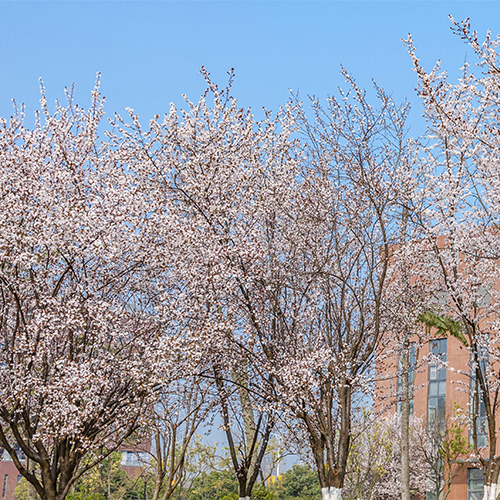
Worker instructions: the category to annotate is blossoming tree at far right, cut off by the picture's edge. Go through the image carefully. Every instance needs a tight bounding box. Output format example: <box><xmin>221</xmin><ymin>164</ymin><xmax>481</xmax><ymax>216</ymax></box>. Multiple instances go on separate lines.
<box><xmin>407</xmin><ymin>20</ymin><xmax>500</xmax><ymax>500</ymax></box>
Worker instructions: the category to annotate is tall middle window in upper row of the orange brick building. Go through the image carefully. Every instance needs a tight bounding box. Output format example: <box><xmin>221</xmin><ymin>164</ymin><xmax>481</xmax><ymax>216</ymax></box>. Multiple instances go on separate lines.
<box><xmin>427</xmin><ymin>339</ymin><xmax>447</xmax><ymax>427</ymax></box>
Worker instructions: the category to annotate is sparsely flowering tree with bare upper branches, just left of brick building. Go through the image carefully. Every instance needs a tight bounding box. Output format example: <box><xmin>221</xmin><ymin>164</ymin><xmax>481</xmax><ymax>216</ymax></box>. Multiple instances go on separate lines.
<box><xmin>174</xmin><ymin>75</ymin><xmax>416</xmax><ymax>499</ymax></box>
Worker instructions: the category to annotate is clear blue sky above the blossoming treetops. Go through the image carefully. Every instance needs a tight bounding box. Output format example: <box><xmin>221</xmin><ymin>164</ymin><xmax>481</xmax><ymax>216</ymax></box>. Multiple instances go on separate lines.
<box><xmin>0</xmin><ymin>0</ymin><xmax>500</xmax><ymax>135</ymax></box>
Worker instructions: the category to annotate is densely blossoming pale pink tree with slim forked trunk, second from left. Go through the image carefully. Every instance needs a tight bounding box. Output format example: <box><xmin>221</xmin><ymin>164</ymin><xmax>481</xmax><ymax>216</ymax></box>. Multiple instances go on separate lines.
<box><xmin>116</xmin><ymin>73</ymin><xmax>296</xmax><ymax>498</ymax></box>
